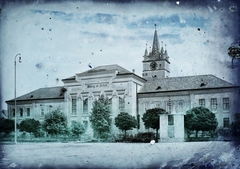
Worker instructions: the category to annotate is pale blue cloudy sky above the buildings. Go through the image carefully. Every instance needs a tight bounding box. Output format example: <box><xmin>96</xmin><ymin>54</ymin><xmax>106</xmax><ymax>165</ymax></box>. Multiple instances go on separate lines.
<box><xmin>0</xmin><ymin>0</ymin><xmax>240</xmax><ymax>110</ymax></box>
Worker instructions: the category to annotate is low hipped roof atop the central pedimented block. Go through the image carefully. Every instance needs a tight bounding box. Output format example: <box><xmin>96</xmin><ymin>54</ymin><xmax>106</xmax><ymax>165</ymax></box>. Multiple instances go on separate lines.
<box><xmin>77</xmin><ymin>64</ymin><xmax>132</xmax><ymax>76</ymax></box>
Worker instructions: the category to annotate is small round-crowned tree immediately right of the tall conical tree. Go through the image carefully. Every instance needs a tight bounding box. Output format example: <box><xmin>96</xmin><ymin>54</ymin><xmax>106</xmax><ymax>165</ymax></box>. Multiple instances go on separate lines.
<box><xmin>115</xmin><ymin>112</ymin><xmax>137</xmax><ymax>138</ymax></box>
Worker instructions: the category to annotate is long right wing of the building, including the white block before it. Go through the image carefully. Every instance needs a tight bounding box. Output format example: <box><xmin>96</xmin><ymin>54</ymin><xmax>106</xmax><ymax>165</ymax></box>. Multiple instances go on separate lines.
<box><xmin>138</xmin><ymin>75</ymin><xmax>240</xmax><ymax>142</ymax></box>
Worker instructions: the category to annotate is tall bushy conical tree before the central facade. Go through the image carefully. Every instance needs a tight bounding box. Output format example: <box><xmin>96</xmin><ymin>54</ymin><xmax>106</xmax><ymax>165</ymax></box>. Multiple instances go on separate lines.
<box><xmin>89</xmin><ymin>95</ymin><xmax>111</xmax><ymax>139</ymax></box>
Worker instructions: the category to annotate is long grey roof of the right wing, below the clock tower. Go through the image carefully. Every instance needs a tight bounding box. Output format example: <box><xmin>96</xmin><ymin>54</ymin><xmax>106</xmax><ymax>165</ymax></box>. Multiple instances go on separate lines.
<box><xmin>139</xmin><ymin>75</ymin><xmax>234</xmax><ymax>93</ymax></box>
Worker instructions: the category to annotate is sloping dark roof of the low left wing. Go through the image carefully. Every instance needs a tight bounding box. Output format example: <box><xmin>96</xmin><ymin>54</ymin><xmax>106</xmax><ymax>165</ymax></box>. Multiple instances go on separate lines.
<box><xmin>6</xmin><ymin>86</ymin><xmax>66</xmax><ymax>102</ymax></box>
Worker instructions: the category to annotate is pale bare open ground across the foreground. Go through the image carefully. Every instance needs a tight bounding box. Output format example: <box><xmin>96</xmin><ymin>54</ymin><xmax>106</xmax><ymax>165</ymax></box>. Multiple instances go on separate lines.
<box><xmin>0</xmin><ymin>142</ymin><xmax>240</xmax><ymax>169</ymax></box>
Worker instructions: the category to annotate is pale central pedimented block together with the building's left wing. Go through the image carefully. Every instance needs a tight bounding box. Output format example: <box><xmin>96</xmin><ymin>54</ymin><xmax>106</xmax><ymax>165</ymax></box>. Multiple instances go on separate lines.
<box><xmin>6</xmin><ymin>65</ymin><xmax>146</xmax><ymax>136</ymax></box>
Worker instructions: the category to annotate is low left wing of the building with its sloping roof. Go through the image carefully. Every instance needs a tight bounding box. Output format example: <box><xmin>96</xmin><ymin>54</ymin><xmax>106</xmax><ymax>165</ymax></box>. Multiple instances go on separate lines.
<box><xmin>6</xmin><ymin>86</ymin><xmax>65</xmax><ymax>123</ymax></box>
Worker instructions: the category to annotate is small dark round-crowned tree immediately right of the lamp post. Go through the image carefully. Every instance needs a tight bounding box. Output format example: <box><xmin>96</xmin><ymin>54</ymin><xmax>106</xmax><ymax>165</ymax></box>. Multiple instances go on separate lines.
<box><xmin>19</xmin><ymin>119</ymin><xmax>41</xmax><ymax>137</ymax></box>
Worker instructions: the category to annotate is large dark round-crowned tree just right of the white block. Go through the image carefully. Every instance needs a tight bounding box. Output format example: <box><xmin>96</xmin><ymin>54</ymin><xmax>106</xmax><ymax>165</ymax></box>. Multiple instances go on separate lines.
<box><xmin>184</xmin><ymin>107</ymin><xmax>218</xmax><ymax>138</ymax></box>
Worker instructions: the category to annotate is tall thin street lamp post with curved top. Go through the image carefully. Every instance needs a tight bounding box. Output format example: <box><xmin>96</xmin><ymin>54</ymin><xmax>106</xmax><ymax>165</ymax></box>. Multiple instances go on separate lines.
<box><xmin>14</xmin><ymin>53</ymin><xmax>21</xmax><ymax>144</ymax></box>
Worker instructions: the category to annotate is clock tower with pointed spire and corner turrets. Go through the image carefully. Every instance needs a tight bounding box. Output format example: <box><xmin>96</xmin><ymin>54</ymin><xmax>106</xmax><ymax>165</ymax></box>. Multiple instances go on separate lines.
<box><xmin>142</xmin><ymin>24</ymin><xmax>170</xmax><ymax>80</ymax></box>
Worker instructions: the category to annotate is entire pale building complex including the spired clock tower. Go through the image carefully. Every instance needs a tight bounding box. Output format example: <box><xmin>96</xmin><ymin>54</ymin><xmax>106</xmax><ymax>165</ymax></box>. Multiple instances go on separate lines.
<box><xmin>6</xmin><ymin>30</ymin><xmax>240</xmax><ymax>141</ymax></box>
